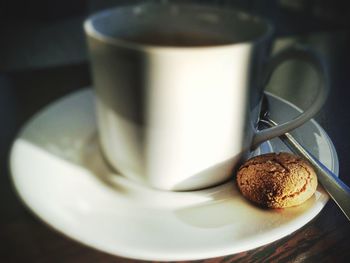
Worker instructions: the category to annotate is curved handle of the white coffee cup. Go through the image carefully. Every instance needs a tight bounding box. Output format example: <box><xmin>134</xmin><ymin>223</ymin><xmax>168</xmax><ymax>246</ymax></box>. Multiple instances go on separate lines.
<box><xmin>252</xmin><ymin>46</ymin><xmax>329</xmax><ymax>147</ymax></box>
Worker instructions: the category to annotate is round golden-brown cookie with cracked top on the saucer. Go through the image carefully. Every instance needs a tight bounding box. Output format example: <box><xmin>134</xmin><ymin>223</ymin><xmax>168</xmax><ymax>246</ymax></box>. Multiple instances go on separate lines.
<box><xmin>237</xmin><ymin>153</ymin><xmax>317</xmax><ymax>208</ymax></box>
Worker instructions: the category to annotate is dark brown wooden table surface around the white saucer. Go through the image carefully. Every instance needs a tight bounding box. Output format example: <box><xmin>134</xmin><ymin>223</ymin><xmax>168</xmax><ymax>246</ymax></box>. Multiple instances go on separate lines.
<box><xmin>0</xmin><ymin>26</ymin><xmax>350</xmax><ymax>262</ymax></box>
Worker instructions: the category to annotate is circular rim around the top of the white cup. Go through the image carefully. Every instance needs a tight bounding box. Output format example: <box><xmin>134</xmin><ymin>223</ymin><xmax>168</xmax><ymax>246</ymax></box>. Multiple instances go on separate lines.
<box><xmin>83</xmin><ymin>3</ymin><xmax>274</xmax><ymax>51</ymax></box>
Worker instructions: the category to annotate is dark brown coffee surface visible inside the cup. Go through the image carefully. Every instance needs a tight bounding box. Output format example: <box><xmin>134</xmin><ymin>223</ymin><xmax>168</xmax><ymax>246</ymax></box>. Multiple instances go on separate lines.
<box><xmin>122</xmin><ymin>32</ymin><xmax>233</xmax><ymax>47</ymax></box>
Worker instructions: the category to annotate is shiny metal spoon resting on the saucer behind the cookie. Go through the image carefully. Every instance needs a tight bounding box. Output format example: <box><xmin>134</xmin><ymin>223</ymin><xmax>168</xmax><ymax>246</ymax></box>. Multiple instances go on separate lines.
<box><xmin>260</xmin><ymin>95</ymin><xmax>350</xmax><ymax>221</ymax></box>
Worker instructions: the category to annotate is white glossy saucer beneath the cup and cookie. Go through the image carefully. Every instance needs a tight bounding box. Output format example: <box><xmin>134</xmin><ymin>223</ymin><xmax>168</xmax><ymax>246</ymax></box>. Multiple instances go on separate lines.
<box><xmin>10</xmin><ymin>89</ymin><xmax>338</xmax><ymax>260</ymax></box>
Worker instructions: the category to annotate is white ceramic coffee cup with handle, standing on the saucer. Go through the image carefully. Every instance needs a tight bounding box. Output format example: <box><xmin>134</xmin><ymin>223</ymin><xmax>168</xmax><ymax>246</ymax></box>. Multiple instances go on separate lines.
<box><xmin>84</xmin><ymin>4</ymin><xmax>328</xmax><ymax>190</ymax></box>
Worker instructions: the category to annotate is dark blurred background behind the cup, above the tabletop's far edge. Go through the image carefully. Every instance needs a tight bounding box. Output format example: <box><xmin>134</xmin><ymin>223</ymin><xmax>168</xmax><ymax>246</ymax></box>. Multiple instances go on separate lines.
<box><xmin>0</xmin><ymin>0</ymin><xmax>350</xmax><ymax>71</ymax></box>
